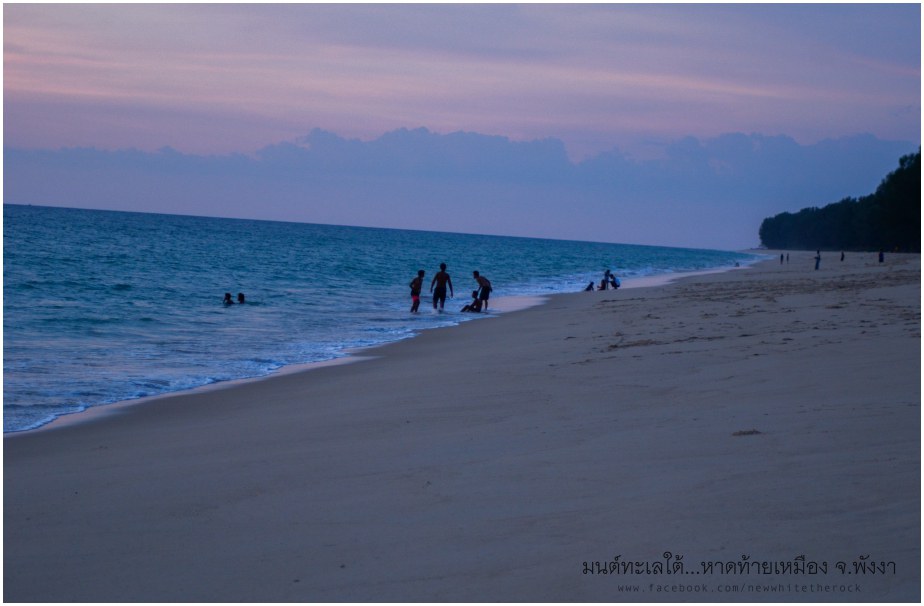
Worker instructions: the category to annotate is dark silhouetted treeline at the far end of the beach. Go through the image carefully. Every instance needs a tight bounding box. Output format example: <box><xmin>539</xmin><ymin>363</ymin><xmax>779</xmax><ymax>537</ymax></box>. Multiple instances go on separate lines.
<box><xmin>760</xmin><ymin>149</ymin><xmax>921</xmax><ymax>252</ymax></box>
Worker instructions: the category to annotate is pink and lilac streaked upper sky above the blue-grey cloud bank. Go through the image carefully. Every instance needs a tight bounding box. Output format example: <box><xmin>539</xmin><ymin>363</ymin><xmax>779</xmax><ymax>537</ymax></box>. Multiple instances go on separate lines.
<box><xmin>4</xmin><ymin>4</ymin><xmax>920</xmax><ymax>156</ymax></box>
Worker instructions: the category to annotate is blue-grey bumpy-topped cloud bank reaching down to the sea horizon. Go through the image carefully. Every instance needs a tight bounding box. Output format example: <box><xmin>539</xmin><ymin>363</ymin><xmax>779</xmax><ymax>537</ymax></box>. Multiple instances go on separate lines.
<box><xmin>4</xmin><ymin>129</ymin><xmax>918</xmax><ymax>249</ymax></box>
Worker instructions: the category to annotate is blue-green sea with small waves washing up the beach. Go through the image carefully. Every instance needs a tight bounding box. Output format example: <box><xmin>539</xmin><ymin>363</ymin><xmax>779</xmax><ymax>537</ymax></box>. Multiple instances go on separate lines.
<box><xmin>3</xmin><ymin>204</ymin><xmax>761</xmax><ymax>433</ymax></box>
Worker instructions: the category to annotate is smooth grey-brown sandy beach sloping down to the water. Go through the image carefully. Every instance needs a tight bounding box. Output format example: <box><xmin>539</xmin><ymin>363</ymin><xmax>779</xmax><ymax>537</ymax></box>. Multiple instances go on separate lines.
<box><xmin>3</xmin><ymin>252</ymin><xmax>921</xmax><ymax>602</ymax></box>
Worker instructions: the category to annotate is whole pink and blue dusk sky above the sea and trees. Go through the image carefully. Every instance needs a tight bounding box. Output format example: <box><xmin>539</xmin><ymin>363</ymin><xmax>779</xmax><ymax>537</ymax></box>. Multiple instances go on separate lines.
<box><xmin>3</xmin><ymin>3</ymin><xmax>921</xmax><ymax>248</ymax></box>
